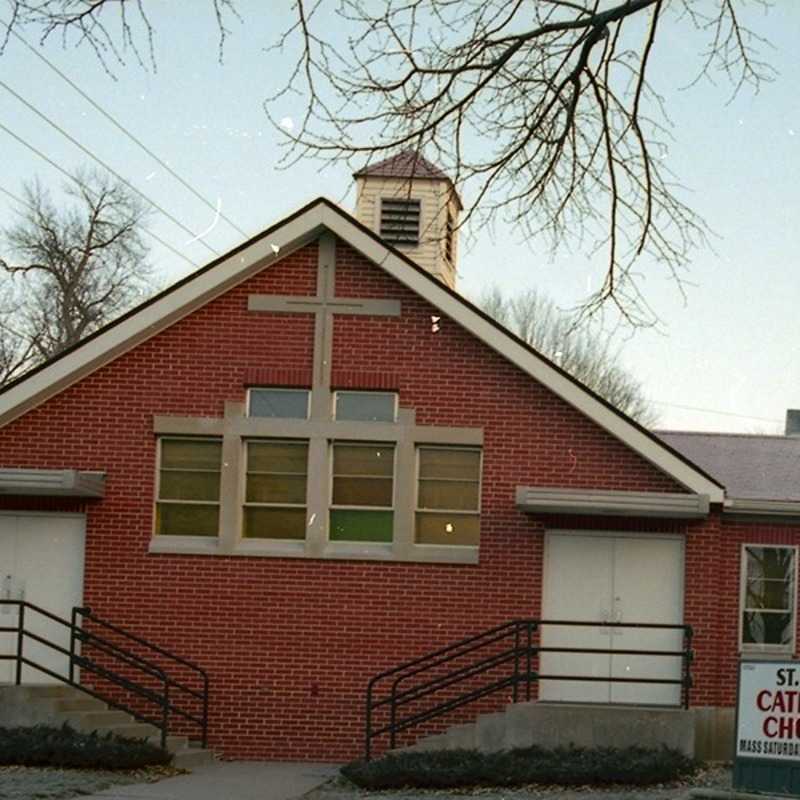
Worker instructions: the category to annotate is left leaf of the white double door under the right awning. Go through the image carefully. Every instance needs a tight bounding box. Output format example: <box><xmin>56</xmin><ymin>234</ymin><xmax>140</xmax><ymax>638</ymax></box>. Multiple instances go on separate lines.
<box><xmin>539</xmin><ymin>534</ymin><xmax>613</xmax><ymax>703</ymax></box>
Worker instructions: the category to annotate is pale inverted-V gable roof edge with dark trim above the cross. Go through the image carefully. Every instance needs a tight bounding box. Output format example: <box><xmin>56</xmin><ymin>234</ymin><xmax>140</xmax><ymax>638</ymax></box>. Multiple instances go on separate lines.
<box><xmin>0</xmin><ymin>197</ymin><xmax>724</xmax><ymax>503</ymax></box>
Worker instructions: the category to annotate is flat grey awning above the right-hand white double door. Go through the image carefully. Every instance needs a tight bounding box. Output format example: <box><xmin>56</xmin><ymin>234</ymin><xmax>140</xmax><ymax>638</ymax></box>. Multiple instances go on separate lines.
<box><xmin>517</xmin><ymin>486</ymin><xmax>709</xmax><ymax>519</ymax></box>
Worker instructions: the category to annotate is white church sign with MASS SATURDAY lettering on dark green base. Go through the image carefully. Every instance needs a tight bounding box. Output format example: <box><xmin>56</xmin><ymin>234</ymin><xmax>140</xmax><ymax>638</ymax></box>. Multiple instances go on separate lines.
<box><xmin>733</xmin><ymin>661</ymin><xmax>800</xmax><ymax>797</ymax></box>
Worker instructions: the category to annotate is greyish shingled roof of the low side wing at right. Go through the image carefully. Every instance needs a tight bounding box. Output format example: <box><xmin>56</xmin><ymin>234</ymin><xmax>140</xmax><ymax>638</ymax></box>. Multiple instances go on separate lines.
<box><xmin>658</xmin><ymin>431</ymin><xmax>800</xmax><ymax>501</ymax></box>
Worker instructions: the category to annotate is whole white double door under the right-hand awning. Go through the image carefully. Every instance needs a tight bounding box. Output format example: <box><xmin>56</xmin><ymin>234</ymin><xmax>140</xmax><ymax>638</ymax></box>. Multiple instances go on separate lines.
<box><xmin>539</xmin><ymin>533</ymin><xmax>684</xmax><ymax>705</ymax></box>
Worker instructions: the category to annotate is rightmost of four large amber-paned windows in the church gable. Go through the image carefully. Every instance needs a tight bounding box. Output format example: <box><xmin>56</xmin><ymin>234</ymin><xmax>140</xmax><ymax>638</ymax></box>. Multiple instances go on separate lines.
<box><xmin>415</xmin><ymin>446</ymin><xmax>481</xmax><ymax>547</ymax></box>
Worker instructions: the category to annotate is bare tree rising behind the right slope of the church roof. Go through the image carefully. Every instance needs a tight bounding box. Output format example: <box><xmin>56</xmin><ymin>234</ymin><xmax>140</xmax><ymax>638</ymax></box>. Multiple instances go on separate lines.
<box><xmin>478</xmin><ymin>286</ymin><xmax>658</xmax><ymax>427</ymax></box>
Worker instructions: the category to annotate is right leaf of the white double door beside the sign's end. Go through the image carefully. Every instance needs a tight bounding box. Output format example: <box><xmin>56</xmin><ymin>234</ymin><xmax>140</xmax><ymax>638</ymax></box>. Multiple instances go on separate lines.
<box><xmin>611</xmin><ymin>538</ymin><xmax>683</xmax><ymax>705</ymax></box>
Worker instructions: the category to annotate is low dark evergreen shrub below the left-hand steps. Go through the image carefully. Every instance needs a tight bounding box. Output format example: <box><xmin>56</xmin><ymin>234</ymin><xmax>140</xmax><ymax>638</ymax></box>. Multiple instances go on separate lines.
<box><xmin>0</xmin><ymin>724</ymin><xmax>172</xmax><ymax>770</ymax></box>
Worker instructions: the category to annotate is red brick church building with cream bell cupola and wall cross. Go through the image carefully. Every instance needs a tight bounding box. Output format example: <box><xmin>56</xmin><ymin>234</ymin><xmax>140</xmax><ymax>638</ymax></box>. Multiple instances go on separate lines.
<box><xmin>0</xmin><ymin>155</ymin><xmax>800</xmax><ymax>760</ymax></box>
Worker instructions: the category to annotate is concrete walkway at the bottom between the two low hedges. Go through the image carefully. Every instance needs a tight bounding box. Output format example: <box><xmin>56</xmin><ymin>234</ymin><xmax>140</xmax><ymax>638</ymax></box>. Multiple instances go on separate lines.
<box><xmin>84</xmin><ymin>761</ymin><xmax>339</xmax><ymax>800</ymax></box>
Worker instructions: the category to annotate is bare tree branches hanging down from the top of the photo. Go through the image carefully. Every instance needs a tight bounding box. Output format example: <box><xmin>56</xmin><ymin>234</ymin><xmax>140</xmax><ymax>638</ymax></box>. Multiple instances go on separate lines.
<box><xmin>1</xmin><ymin>0</ymin><xmax>772</xmax><ymax>325</ymax></box>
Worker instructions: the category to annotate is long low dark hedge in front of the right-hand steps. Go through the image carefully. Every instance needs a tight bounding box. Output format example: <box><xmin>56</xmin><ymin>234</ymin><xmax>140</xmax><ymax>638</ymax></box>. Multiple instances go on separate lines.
<box><xmin>342</xmin><ymin>747</ymin><xmax>699</xmax><ymax>789</ymax></box>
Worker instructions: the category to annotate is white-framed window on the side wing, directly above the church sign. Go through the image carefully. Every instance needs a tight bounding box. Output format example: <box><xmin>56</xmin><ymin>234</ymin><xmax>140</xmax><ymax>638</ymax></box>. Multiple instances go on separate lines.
<box><xmin>741</xmin><ymin>545</ymin><xmax>797</xmax><ymax>653</ymax></box>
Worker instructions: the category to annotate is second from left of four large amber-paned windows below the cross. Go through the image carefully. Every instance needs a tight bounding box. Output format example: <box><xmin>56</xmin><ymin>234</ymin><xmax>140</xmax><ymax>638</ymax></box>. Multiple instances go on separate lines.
<box><xmin>242</xmin><ymin>439</ymin><xmax>308</xmax><ymax>540</ymax></box>
